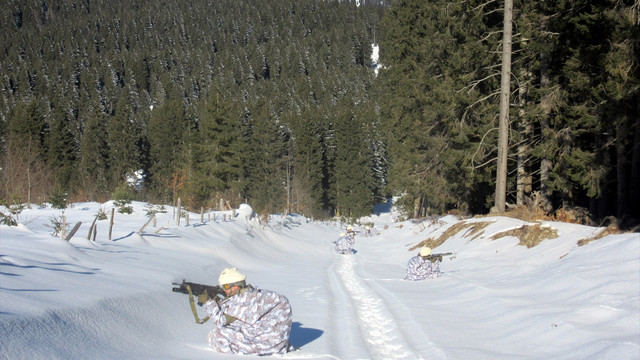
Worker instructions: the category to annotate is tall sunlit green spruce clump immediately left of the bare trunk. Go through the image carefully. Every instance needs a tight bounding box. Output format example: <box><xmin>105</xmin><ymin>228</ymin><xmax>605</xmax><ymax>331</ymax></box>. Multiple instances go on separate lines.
<box><xmin>379</xmin><ymin>1</ymin><xmax>499</xmax><ymax>216</ymax></box>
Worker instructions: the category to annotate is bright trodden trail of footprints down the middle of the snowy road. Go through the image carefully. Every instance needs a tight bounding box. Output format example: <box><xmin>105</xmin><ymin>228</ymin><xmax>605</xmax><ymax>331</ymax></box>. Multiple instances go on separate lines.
<box><xmin>337</xmin><ymin>256</ymin><xmax>423</xmax><ymax>360</ymax></box>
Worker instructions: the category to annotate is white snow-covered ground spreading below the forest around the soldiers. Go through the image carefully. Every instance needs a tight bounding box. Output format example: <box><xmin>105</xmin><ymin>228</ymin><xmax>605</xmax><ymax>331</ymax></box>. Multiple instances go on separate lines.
<box><xmin>0</xmin><ymin>202</ymin><xmax>640</xmax><ymax>360</ymax></box>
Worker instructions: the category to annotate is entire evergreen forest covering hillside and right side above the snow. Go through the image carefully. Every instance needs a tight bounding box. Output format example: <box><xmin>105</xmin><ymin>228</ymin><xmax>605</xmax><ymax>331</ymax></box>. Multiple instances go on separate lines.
<box><xmin>0</xmin><ymin>0</ymin><xmax>640</xmax><ymax>225</ymax></box>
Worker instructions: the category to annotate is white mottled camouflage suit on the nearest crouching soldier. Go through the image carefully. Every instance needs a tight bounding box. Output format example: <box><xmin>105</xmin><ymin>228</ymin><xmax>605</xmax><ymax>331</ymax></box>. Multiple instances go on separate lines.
<box><xmin>204</xmin><ymin>286</ymin><xmax>291</xmax><ymax>355</ymax></box>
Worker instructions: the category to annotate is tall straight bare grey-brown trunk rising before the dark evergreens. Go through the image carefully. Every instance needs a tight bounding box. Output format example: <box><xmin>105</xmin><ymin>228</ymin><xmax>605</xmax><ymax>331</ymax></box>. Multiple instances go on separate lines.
<box><xmin>495</xmin><ymin>0</ymin><xmax>513</xmax><ymax>213</ymax></box>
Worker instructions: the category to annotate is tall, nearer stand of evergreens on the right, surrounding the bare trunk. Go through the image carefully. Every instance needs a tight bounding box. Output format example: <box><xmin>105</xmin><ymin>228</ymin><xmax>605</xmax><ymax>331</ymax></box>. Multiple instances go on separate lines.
<box><xmin>380</xmin><ymin>0</ymin><xmax>640</xmax><ymax>225</ymax></box>
